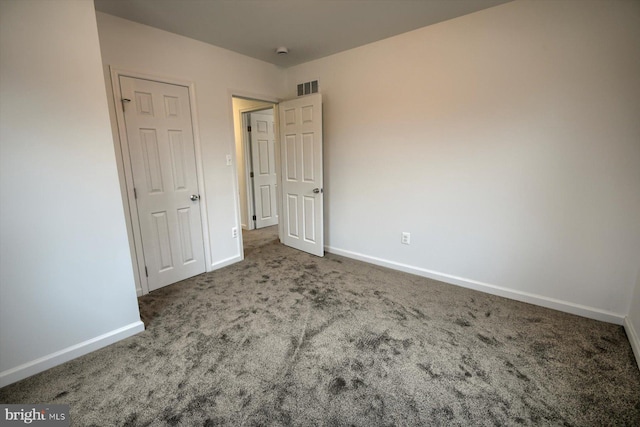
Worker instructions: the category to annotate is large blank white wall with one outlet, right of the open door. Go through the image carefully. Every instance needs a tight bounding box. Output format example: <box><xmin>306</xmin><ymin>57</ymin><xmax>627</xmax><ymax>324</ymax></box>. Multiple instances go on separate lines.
<box><xmin>287</xmin><ymin>0</ymin><xmax>640</xmax><ymax>323</ymax></box>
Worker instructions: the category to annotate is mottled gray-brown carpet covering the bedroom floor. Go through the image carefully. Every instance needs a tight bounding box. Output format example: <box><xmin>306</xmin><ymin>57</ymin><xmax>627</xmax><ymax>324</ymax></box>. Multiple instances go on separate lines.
<box><xmin>0</xmin><ymin>228</ymin><xmax>640</xmax><ymax>426</ymax></box>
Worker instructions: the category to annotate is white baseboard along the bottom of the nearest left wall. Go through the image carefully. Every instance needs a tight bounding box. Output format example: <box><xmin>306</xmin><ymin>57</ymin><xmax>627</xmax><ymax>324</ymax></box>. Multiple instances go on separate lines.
<box><xmin>0</xmin><ymin>321</ymin><xmax>144</xmax><ymax>387</ymax></box>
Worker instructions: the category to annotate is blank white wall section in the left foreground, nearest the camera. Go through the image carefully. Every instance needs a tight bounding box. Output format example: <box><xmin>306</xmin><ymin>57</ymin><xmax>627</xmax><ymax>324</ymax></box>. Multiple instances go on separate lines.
<box><xmin>0</xmin><ymin>0</ymin><xmax>144</xmax><ymax>386</ymax></box>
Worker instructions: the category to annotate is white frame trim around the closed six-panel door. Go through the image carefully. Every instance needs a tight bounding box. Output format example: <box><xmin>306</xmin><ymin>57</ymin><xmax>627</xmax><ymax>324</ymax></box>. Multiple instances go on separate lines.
<box><xmin>109</xmin><ymin>66</ymin><xmax>212</xmax><ymax>296</ymax></box>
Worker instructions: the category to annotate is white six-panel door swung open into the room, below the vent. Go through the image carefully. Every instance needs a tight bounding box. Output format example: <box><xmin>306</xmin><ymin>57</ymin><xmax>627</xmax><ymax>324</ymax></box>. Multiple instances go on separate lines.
<box><xmin>279</xmin><ymin>94</ymin><xmax>324</xmax><ymax>256</ymax></box>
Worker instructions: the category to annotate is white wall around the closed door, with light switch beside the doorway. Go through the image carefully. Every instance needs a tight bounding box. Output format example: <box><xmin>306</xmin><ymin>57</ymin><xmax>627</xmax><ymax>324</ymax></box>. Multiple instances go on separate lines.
<box><xmin>97</xmin><ymin>12</ymin><xmax>284</xmax><ymax>278</ymax></box>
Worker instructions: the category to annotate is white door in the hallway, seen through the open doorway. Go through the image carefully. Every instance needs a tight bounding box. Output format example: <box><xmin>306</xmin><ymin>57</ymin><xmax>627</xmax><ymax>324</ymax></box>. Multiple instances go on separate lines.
<box><xmin>251</xmin><ymin>113</ymin><xmax>278</xmax><ymax>228</ymax></box>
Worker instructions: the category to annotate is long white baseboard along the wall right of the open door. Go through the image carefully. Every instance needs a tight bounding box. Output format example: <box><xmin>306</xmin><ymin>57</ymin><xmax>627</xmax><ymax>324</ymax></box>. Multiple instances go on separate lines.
<box><xmin>325</xmin><ymin>246</ymin><xmax>624</xmax><ymax>325</ymax></box>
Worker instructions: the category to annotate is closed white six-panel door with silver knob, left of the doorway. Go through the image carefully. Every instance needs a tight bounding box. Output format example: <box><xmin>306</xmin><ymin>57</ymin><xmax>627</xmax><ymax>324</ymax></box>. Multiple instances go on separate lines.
<box><xmin>120</xmin><ymin>76</ymin><xmax>205</xmax><ymax>291</ymax></box>
